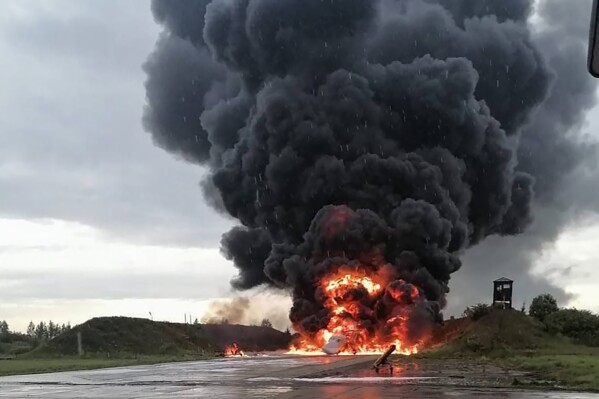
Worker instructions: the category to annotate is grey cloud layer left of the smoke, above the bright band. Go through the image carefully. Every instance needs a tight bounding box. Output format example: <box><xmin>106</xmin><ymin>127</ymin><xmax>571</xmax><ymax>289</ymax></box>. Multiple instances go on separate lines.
<box><xmin>0</xmin><ymin>1</ymin><xmax>229</xmax><ymax>247</ymax></box>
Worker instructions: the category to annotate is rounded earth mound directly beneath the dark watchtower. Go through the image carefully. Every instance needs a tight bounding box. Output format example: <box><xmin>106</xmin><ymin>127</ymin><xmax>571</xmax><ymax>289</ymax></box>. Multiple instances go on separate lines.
<box><xmin>431</xmin><ymin>310</ymin><xmax>558</xmax><ymax>355</ymax></box>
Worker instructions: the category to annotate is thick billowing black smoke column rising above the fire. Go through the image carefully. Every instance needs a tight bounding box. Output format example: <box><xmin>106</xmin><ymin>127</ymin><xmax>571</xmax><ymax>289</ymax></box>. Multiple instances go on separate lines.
<box><xmin>144</xmin><ymin>0</ymin><xmax>596</xmax><ymax>331</ymax></box>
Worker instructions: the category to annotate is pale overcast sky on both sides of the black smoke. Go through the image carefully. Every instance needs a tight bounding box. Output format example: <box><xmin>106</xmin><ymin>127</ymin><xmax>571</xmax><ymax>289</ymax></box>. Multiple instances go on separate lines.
<box><xmin>0</xmin><ymin>0</ymin><xmax>599</xmax><ymax>329</ymax></box>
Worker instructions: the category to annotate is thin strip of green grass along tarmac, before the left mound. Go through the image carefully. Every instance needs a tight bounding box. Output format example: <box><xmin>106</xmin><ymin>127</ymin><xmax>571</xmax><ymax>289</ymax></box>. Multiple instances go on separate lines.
<box><xmin>0</xmin><ymin>355</ymin><xmax>214</xmax><ymax>376</ymax></box>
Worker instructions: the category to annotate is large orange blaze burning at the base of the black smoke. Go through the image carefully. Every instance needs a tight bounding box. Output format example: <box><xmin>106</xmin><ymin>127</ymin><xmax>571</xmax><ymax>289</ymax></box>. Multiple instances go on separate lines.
<box><xmin>290</xmin><ymin>267</ymin><xmax>420</xmax><ymax>355</ymax></box>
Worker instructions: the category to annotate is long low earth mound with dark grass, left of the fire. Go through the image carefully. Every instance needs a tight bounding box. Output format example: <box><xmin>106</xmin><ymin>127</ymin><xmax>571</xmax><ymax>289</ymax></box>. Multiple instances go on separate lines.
<box><xmin>31</xmin><ymin>317</ymin><xmax>289</xmax><ymax>356</ymax></box>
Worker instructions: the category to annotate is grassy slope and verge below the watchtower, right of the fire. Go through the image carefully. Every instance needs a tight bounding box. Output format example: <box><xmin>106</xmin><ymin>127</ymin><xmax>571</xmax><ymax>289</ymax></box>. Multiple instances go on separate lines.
<box><xmin>415</xmin><ymin>312</ymin><xmax>599</xmax><ymax>392</ymax></box>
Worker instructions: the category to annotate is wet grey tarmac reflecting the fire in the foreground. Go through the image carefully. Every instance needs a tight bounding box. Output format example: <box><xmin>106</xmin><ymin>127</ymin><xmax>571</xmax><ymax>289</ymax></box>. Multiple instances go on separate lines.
<box><xmin>0</xmin><ymin>357</ymin><xmax>599</xmax><ymax>399</ymax></box>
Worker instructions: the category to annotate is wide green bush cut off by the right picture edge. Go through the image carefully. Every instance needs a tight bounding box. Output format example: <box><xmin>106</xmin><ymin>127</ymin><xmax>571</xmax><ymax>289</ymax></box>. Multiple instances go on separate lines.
<box><xmin>545</xmin><ymin>309</ymin><xmax>599</xmax><ymax>346</ymax></box>
